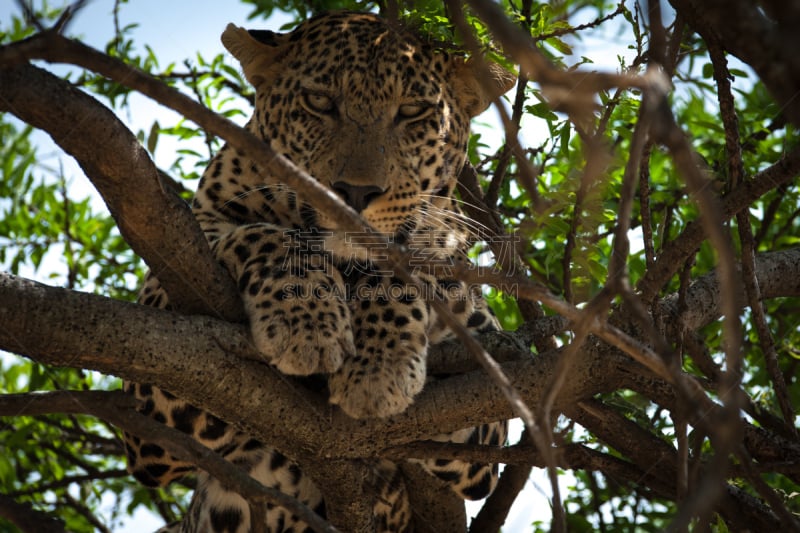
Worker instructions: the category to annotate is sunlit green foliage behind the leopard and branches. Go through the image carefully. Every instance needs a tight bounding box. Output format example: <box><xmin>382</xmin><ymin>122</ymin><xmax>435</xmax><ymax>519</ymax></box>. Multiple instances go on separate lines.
<box><xmin>0</xmin><ymin>0</ymin><xmax>800</xmax><ymax>531</ymax></box>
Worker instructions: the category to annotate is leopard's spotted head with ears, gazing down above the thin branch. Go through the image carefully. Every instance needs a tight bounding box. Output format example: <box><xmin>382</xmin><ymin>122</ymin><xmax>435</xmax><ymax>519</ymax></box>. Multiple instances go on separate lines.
<box><xmin>222</xmin><ymin>12</ymin><xmax>515</xmax><ymax>239</ymax></box>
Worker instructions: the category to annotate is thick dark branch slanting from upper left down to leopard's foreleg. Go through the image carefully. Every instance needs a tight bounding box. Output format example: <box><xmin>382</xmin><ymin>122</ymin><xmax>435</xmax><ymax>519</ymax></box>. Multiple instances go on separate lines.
<box><xmin>0</xmin><ymin>65</ymin><xmax>244</xmax><ymax>321</ymax></box>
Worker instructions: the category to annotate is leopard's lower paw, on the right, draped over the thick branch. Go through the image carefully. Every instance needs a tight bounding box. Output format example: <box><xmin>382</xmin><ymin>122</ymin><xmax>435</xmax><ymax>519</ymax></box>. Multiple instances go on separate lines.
<box><xmin>328</xmin><ymin>354</ymin><xmax>425</xmax><ymax>418</ymax></box>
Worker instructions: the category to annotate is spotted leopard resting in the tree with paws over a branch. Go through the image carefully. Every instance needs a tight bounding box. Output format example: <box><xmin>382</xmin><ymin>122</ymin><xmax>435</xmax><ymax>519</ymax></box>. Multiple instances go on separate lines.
<box><xmin>124</xmin><ymin>11</ymin><xmax>516</xmax><ymax>533</ymax></box>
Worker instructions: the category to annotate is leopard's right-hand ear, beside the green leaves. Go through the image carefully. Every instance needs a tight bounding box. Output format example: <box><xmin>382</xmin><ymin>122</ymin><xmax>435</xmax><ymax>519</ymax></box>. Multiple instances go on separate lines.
<box><xmin>453</xmin><ymin>57</ymin><xmax>517</xmax><ymax>117</ymax></box>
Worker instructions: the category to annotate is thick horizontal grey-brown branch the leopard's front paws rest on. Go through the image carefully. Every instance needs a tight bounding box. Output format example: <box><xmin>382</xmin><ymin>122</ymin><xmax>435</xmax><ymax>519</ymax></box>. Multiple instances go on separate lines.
<box><xmin>0</xmin><ymin>243</ymin><xmax>800</xmax><ymax>464</ymax></box>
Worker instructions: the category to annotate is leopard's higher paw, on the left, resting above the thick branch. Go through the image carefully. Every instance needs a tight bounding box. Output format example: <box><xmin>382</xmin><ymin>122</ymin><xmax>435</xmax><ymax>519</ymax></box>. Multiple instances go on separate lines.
<box><xmin>251</xmin><ymin>301</ymin><xmax>355</xmax><ymax>376</ymax></box>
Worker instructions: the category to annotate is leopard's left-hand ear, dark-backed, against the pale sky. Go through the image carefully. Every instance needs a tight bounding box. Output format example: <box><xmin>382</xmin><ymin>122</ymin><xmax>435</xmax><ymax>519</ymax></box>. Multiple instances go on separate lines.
<box><xmin>222</xmin><ymin>24</ymin><xmax>285</xmax><ymax>88</ymax></box>
